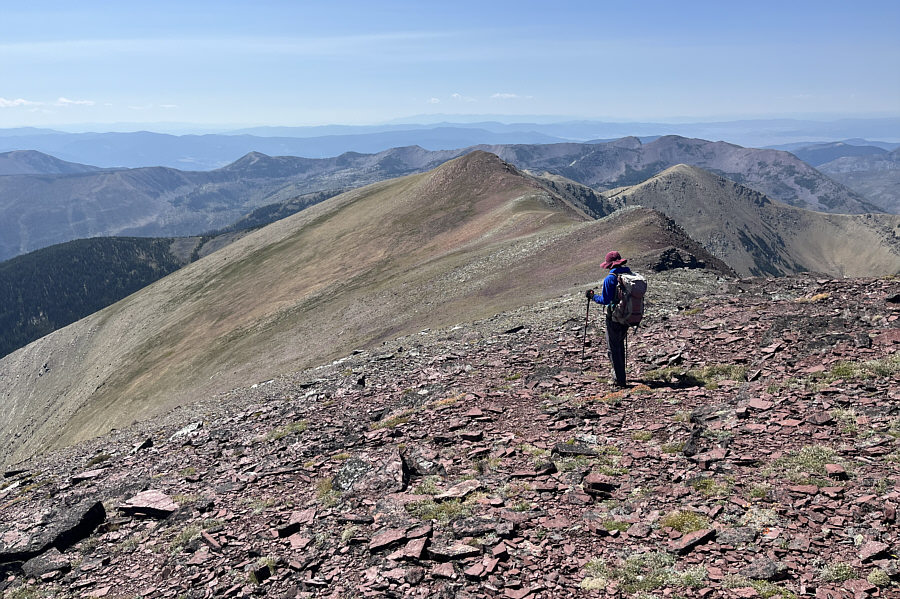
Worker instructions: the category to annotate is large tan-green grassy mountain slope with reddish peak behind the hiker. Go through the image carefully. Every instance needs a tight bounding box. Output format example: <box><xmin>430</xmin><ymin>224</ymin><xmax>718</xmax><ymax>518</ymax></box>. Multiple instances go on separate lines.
<box><xmin>0</xmin><ymin>152</ymin><xmax>724</xmax><ymax>460</ymax></box>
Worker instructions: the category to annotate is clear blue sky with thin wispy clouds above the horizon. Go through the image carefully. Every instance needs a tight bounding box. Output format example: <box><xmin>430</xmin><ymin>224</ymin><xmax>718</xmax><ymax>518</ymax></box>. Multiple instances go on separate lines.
<box><xmin>0</xmin><ymin>0</ymin><xmax>900</xmax><ymax>127</ymax></box>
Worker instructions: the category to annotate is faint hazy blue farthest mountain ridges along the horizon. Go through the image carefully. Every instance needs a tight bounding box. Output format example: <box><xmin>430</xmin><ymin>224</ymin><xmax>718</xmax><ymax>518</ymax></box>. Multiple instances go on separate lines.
<box><xmin>0</xmin><ymin>115</ymin><xmax>900</xmax><ymax>170</ymax></box>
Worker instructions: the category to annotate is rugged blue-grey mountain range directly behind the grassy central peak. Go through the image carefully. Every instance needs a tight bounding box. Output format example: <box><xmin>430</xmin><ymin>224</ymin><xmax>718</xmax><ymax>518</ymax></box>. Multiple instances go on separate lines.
<box><xmin>0</xmin><ymin>136</ymin><xmax>879</xmax><ymax>259</ymax></box>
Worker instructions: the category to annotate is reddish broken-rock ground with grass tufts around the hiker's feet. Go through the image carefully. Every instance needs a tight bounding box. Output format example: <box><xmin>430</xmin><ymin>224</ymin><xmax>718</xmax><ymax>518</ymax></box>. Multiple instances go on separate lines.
<box><xmin>0</xmin><ymin>271</ymin><xmax>900</xmax><ymax>599</ymax></box>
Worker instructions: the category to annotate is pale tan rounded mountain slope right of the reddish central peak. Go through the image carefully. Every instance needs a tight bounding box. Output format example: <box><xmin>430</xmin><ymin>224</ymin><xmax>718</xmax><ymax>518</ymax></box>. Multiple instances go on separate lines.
<box><xmin>608</xmin><ymin>165</ymin><xmax>900</xmax><ymax>276</ymax></box>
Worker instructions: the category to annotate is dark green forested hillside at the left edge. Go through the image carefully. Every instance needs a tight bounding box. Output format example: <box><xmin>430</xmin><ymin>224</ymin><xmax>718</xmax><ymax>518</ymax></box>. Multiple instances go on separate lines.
<box><xmin>0</xmin><ymin>237</ymin><xmax>187</xmax><ymax>356</ymax></box>
